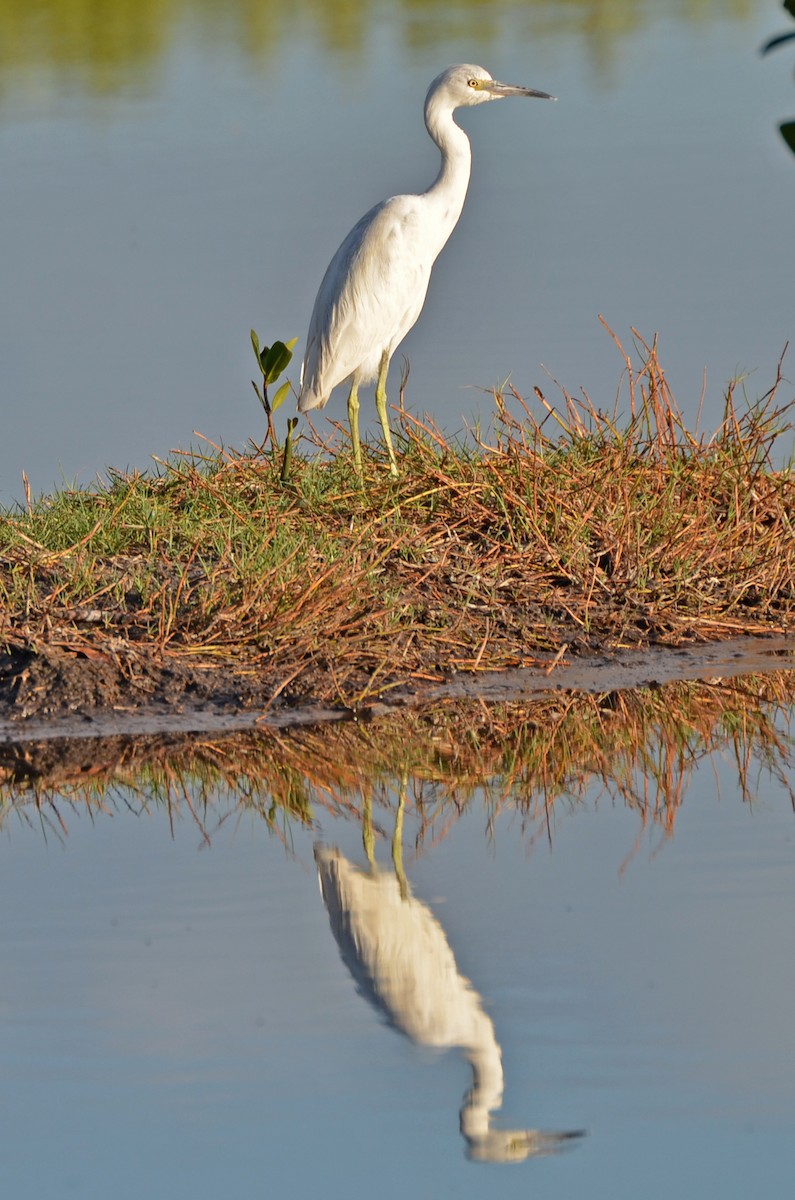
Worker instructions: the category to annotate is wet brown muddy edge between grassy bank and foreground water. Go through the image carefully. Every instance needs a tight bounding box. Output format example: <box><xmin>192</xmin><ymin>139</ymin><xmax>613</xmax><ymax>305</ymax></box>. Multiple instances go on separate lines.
<box><xmin>0</xmin><ymin>635</ymin><xmax>795</xmax><ymax>744</ymax></box>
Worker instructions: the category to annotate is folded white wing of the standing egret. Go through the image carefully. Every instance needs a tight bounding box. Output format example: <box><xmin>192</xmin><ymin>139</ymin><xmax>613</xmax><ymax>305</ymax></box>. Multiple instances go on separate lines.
<box><xmin>301</xmin><ymin>196</ymin><xmax>432</xmax><ymax>408</ymax></box>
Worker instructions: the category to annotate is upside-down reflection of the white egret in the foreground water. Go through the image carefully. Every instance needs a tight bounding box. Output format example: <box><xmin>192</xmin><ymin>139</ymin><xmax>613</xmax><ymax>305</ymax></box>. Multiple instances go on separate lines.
<box><xmin>315</xmin><ymin>798</ymin><xmax>582</xmax><ymax>1163</ymax></box>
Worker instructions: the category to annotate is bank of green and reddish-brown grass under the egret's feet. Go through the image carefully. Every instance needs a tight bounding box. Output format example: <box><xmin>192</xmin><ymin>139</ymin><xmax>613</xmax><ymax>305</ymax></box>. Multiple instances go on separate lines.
<box><xmin>0</xmin><ymin>333</ymin><xmax>795</xmax><ymax>703</ymax></box>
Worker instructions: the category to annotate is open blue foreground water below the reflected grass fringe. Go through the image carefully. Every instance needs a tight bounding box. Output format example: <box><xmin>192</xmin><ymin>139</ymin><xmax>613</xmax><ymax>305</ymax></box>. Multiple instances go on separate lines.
<box><xmin>0</xmin><ymin>729</ymin><xmax>795</xmax><ymax>1200</ymax></box>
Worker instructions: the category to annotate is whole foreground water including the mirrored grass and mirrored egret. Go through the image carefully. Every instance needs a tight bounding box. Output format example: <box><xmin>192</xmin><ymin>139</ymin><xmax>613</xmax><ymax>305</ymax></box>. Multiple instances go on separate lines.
<box><xmin>0</xmin><ymin>672</ymin><xmax>795</xmax><ymax>1200</ymax></box>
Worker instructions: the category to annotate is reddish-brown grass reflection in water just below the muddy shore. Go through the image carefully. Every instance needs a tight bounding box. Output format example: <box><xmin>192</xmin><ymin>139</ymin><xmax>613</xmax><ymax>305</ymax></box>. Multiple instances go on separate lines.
<box><xmin>0</xmin><ymin>671</ymin><xmax>795</xmax><ymax>852</ymax></box>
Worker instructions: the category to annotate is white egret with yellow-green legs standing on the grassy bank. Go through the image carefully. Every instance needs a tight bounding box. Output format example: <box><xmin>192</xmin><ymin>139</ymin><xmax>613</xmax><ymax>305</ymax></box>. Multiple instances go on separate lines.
<box><xmin>298</xmin><ymin>64</ymin><xmax>555</xmax><ymax>478</ymax></box>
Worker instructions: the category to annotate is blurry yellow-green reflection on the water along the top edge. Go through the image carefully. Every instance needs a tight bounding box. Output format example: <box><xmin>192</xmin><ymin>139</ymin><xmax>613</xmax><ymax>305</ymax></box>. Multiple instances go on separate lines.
<box><xmin>0</xmin><ymin>0</ymin><xmax>754</xmax><ymax>98</ymax></box>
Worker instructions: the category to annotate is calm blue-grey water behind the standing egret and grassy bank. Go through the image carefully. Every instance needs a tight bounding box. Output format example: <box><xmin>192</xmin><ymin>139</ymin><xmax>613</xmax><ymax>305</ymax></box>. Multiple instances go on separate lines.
<box><xmin>0</xmin><ymin>0</ymin><xmax>795</xmax><ymax>503</ymax></box>
